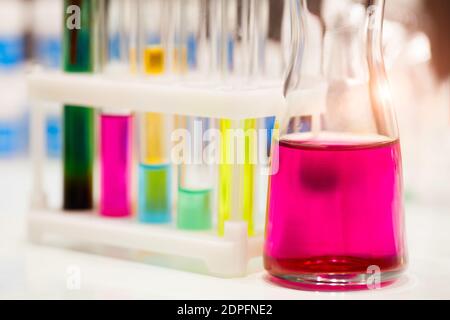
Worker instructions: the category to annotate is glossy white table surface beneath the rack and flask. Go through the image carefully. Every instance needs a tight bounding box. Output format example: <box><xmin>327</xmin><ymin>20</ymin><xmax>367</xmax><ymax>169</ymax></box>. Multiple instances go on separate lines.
<box><xmin>0</xmin><ymin>161</ymin><xmax>450</xmax><ymax>299</ymax></box>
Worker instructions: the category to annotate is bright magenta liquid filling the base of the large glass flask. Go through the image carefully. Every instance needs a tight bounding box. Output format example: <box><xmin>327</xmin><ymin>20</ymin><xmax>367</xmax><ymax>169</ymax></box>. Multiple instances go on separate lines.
<box><xmin>264</xmin><ymin>133</ymin><xmax>406</xmax><ymax>290</ymax></box>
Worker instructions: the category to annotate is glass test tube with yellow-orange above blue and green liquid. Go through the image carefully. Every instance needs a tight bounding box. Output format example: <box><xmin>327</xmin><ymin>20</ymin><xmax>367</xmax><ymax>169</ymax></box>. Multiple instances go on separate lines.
<box><xmin>138</xmin><ymin>0</ymin><xmax>173</xmax><ymax>223</ymax></box>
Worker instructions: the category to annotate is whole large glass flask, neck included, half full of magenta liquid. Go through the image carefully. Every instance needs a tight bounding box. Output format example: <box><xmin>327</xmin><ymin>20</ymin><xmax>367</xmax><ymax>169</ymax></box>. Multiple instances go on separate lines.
<box><xmin>264</xmin><ymin>0</ymin><xmax>406</xmax><ymax>290</ymax></box>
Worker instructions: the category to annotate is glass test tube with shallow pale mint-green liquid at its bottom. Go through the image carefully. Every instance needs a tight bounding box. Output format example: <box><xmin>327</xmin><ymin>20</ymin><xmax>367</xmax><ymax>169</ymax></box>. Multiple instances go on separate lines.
<box><xmin>175</xmin><ymin>0</ymin><xmax>214</xmax><ymax>230</ymax></box>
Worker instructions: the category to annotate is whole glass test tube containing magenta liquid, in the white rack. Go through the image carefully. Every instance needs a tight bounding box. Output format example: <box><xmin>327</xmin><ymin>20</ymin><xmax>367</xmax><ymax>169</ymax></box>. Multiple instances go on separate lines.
<box><xmin>100</xmin><ymin>0</ymin><xmax>137</xmax><ymax>217</ymax></box>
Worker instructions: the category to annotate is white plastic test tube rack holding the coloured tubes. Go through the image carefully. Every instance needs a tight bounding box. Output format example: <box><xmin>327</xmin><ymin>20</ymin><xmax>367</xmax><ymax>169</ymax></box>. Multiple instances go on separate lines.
<box><xmin>27</xmin><ymin>71</ymin><xmax>286</xmax><ymax>278</ymax></box>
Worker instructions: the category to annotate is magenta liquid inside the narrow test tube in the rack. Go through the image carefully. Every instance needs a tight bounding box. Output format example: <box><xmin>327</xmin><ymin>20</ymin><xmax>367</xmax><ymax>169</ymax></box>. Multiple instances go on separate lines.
<box><xmin>100</xmin><ymin>115</ymin><xmax>133</xmax><ymax>217</ymax></box>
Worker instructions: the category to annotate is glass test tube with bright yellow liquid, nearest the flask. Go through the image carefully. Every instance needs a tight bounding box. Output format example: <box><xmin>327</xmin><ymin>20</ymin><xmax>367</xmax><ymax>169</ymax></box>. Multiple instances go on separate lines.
<box><xmin>213</xmin><ymin>0</ymin><xmax>257</xmax><ymax>235</ymax></box>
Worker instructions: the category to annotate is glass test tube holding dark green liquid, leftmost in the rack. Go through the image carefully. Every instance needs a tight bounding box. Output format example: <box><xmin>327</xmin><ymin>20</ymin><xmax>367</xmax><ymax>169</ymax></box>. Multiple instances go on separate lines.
<box><xmin>63</xmin><ymin>0</ymin><xmax>96</xmax><ymax>210</ymax></box>
